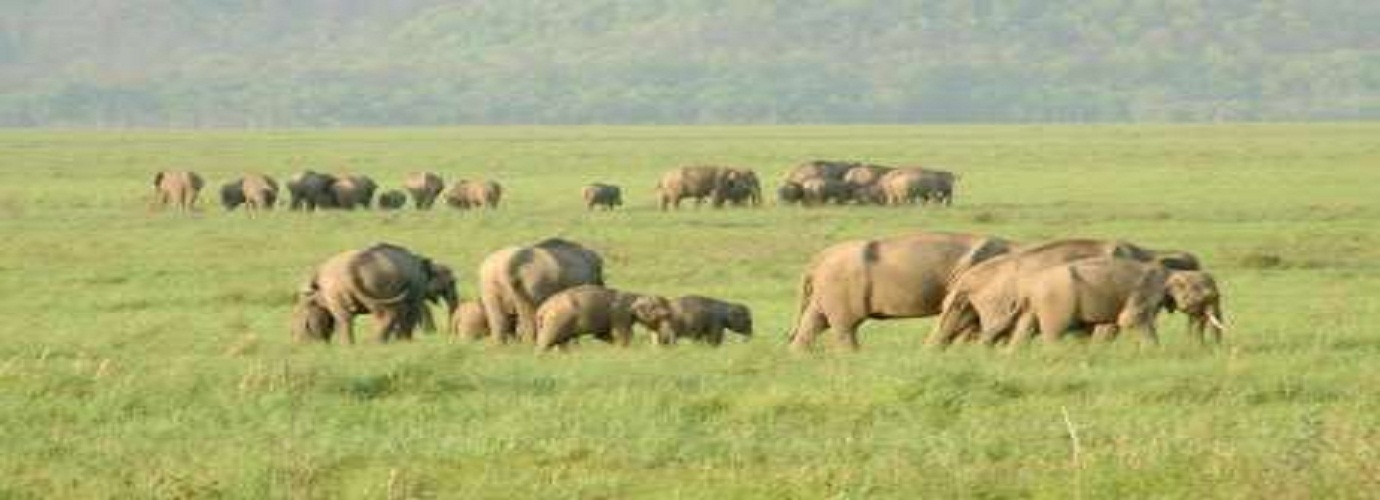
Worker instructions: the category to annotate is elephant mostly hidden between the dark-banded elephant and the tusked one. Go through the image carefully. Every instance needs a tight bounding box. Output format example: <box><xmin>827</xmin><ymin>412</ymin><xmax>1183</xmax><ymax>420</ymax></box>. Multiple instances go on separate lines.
<box><xmin>926</xmin><ymin>239</ymin><xmax>1198</xmax><ymax>347</ymax></box>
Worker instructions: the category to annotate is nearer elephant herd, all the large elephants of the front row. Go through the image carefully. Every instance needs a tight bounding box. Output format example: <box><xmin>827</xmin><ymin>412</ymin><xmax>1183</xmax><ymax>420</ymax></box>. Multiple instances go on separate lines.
<box><xmin>293</xmin><ymin>232</ymin><xmax>1224</xmax><ymax>351</ymax></box>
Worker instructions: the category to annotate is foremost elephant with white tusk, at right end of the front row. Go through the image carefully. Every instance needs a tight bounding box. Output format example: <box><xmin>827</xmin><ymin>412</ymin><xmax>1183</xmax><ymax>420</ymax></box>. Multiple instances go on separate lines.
<box><xmin>1010</xmin><ymin>257</ymin><xmax>1223</xmax><ymax>349</ymax></box>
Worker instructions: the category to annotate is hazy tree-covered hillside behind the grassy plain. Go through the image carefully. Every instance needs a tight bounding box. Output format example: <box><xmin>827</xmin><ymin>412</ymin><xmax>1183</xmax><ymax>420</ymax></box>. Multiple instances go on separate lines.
<box><xmin>0</xmin><ymin>0</ymin><xmax>1380</xmax><ymax>127</ymax></box>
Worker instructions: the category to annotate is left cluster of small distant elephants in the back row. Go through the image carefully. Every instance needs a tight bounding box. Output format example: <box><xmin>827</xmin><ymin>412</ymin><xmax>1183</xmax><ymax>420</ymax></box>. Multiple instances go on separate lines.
<box><xmin>153</xmin><ymin>170</ymin><xmax>504</xmax><ymax>211</ymax></box>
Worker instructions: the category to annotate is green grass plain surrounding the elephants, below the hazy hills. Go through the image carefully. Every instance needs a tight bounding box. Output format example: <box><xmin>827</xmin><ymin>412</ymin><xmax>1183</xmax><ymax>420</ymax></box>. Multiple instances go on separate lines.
<box><xmin>0</xmin><ymin>124</ymin><xmax>1380</xmax><ymax>499</ymax></box>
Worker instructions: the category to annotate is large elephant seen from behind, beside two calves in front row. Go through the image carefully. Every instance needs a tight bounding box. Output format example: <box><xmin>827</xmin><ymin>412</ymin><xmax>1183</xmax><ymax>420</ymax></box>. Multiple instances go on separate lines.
<box><xmin>479</xmin><ymin>238</ymin><xmax>603</xmax><ymax>343</ymax></box>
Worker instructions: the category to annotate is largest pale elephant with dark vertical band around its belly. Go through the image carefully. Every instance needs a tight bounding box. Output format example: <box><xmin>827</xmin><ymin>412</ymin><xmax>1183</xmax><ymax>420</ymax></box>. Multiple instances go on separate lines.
<box><xmin>791</xmin><ymin>232</ymin><xmax>1013</xmax><ymax>349</ymax></box>
